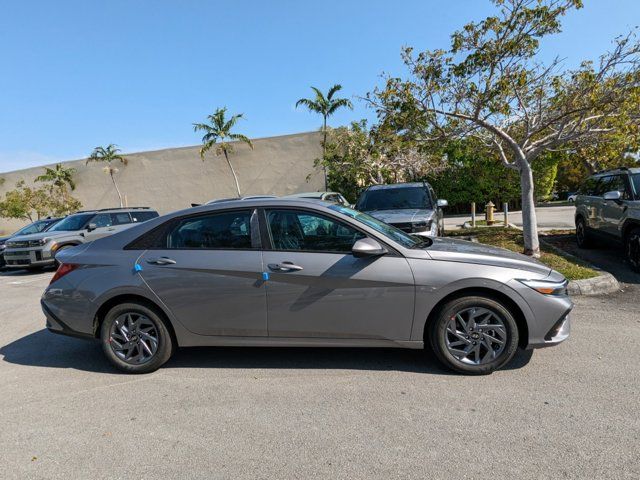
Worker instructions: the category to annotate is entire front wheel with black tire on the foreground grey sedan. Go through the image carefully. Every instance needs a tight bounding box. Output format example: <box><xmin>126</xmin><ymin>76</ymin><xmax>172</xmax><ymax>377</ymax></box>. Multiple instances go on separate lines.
<box><xmin>428</xmin><ymin>296</ymin><xmax>519</xmax><ymax>375</ymax></box>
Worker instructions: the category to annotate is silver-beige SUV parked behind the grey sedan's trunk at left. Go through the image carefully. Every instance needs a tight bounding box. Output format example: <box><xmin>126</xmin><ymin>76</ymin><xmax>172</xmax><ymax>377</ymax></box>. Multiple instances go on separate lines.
<box><xmin>4</xmin><ymin>207</ymin><xmax>158</xmax><ymax>268</ymax></box>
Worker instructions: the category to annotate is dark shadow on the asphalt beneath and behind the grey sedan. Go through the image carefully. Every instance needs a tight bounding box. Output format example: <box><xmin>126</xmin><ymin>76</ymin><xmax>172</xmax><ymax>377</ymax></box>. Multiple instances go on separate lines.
<box><xmin>0</xmin><ymin>329</ymin><xmax>532</xmax><ymax>375</ymax></box>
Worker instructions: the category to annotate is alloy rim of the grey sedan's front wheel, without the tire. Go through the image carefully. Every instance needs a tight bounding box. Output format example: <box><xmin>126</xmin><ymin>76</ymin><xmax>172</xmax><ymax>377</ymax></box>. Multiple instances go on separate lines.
<box><xmin>445</xmin><ymin>307</ymin><xmax>508</xmax><ymax>365</ymax></box>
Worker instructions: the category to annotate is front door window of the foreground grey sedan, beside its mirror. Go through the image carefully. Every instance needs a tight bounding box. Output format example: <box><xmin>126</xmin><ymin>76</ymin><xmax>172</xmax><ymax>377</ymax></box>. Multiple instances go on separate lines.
<box><xmin>267</xmin><ymin>210</ymin><xmax>365</xmax><ymax>253</ymax></box>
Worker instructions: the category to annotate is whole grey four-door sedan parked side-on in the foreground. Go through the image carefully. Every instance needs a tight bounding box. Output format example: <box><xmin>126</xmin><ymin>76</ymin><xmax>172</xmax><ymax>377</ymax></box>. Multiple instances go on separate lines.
<box><xmin>41</xmin><ymin>198</ymin><xmax>572</xmax><ymax>374</ymax></box>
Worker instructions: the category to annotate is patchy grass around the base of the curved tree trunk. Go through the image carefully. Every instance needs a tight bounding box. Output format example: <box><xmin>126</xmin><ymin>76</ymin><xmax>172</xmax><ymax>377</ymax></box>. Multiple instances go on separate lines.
<box><xmin>446</xmin><ymin>228</ymin><xmax>600</xmax><ymax>280</ymax></box>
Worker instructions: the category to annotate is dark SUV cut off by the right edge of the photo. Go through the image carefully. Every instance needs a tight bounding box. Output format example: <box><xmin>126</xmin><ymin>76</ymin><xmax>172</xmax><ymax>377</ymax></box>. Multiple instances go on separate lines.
<box><xmin>576</xmin><ymin>168</ymin><xmax>640</xmax><ymax>272</ymax></box>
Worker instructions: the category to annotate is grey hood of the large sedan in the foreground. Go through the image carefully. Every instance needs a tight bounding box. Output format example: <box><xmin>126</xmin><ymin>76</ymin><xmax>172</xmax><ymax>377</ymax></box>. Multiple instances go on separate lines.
<box><xmin>426</xmin><ymin>237</ymin><xmax>551</xmax><ymax>276</ymax></box>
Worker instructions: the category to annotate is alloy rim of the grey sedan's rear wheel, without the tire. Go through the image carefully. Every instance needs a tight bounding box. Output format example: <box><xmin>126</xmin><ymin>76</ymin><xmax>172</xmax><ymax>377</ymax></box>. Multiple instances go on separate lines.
<box><xmin>109</xmin><ymin>312</ymin><xmax>159</xmax><ymax>365</ymax></box>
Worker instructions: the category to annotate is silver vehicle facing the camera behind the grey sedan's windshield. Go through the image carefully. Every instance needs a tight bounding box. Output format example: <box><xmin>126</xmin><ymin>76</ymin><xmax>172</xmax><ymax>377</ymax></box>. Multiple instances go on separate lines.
<box><xmin>355</xmin><ymin>182</ymin><xmax>448</xmax><ymax>237</ymax></box>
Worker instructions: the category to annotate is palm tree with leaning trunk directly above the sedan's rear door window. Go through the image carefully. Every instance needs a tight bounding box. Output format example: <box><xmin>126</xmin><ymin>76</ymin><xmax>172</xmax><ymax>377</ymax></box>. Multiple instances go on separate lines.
<box><xmin>193</xmin><ymin>107</ymin><xmax>253</xmax><ymax>197</ymax></box>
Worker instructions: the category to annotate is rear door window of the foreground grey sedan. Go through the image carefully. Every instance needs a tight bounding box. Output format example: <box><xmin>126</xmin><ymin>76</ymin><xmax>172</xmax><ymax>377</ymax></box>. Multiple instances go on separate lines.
<box><xmin>163</xmin><ymin>210</ymin><xmax>251</xmax><ymax>250</ymax></box>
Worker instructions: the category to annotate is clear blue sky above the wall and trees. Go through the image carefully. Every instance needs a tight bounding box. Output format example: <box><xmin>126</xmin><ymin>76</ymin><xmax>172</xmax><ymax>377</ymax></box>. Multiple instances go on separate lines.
<box><xmin>0</xmin><ymin>0</ymin><xmax>640</xmax><ymax>171</ymax></box>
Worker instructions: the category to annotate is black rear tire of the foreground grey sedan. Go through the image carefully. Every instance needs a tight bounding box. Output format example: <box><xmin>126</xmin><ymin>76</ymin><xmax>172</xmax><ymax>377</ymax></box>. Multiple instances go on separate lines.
<box><xmin>100</xmin><ymin>302</ymin><xmax>174</xmax><ymax>373</ymax></box>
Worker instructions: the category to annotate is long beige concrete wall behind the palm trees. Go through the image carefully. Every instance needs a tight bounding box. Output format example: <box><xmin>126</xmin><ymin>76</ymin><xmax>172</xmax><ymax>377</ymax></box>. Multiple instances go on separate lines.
<box><xmin>0</xmin><ymin>132</ymin><xmax>323</xmax><ymax>232</ymax></box>
